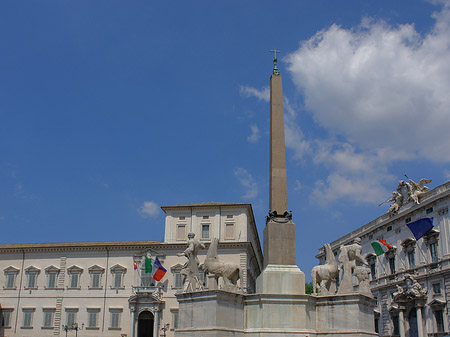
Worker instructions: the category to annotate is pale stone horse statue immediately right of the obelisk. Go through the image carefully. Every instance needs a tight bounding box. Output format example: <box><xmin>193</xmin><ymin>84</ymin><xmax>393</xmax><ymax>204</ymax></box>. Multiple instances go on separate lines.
<box><xmin>311</xmin><ymin>243</ymin><xmax>339</xmax><ymax>295</ymax></box>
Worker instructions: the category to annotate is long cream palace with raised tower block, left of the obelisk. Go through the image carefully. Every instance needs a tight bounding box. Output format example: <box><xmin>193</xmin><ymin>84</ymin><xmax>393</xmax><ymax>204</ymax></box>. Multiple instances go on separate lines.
<box><xmin>0</xmin><ymin>202</ymin><xmax>262</xmax><ymax>337</ymax></box>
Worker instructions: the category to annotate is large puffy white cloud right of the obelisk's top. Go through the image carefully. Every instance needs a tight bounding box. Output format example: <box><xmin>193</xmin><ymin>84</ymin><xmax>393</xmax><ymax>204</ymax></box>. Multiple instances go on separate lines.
<box><xmin>287</xmin><ymin>1</ymin><xmax>450</xmax><ymax>162</ymax></box>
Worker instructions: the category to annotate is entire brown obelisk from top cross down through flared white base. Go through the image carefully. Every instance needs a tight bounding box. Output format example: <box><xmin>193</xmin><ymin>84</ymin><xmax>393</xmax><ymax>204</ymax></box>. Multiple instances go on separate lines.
<box><xmin>257</xmin><ymin>50</ymin><xmax>305</xmax><ymax>294</ymax></box>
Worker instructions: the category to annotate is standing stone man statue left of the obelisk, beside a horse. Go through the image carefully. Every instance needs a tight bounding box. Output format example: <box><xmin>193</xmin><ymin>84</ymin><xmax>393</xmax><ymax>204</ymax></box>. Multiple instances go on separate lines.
<box><xmin>177</xmin><ymin>233</ymin><xmax>206</xmax><ymax>292</ymax></box>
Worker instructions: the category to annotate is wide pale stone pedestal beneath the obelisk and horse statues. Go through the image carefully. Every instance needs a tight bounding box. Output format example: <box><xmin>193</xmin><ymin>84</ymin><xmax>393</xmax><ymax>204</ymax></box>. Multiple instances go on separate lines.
<box><xmin>175</xmin><ymin>290</ymin><xmax>377</xmax><ymax>337</ymax></box>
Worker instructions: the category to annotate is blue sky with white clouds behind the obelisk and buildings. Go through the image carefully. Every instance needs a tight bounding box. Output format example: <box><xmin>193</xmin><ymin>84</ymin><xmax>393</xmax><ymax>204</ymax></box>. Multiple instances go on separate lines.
<box><xmin>0</xmin><ymin>0</ymin><xmax>450</xmax><ymax>278</ymax></box>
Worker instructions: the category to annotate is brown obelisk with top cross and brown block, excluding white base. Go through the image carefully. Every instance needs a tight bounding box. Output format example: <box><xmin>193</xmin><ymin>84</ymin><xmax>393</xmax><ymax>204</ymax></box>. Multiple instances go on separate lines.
<box><xmin>264</xmin><ymin>49</ymin><xmax>296</xmax><ymax>266</ymax></box>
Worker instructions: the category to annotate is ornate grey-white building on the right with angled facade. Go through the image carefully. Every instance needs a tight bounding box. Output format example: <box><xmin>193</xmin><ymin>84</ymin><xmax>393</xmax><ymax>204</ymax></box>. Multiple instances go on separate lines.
<box><xmin>316</xmin><ymin>182</ymin><xmax>450</xmax><ymax>337</ymax></box>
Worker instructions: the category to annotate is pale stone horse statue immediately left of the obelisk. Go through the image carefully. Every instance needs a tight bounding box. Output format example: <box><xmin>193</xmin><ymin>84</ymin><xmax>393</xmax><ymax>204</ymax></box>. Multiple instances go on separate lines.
<box><xmin>203</xmin><ymin>238</ymin><xmax>242</xmax><ymax>291</ymax></box>
